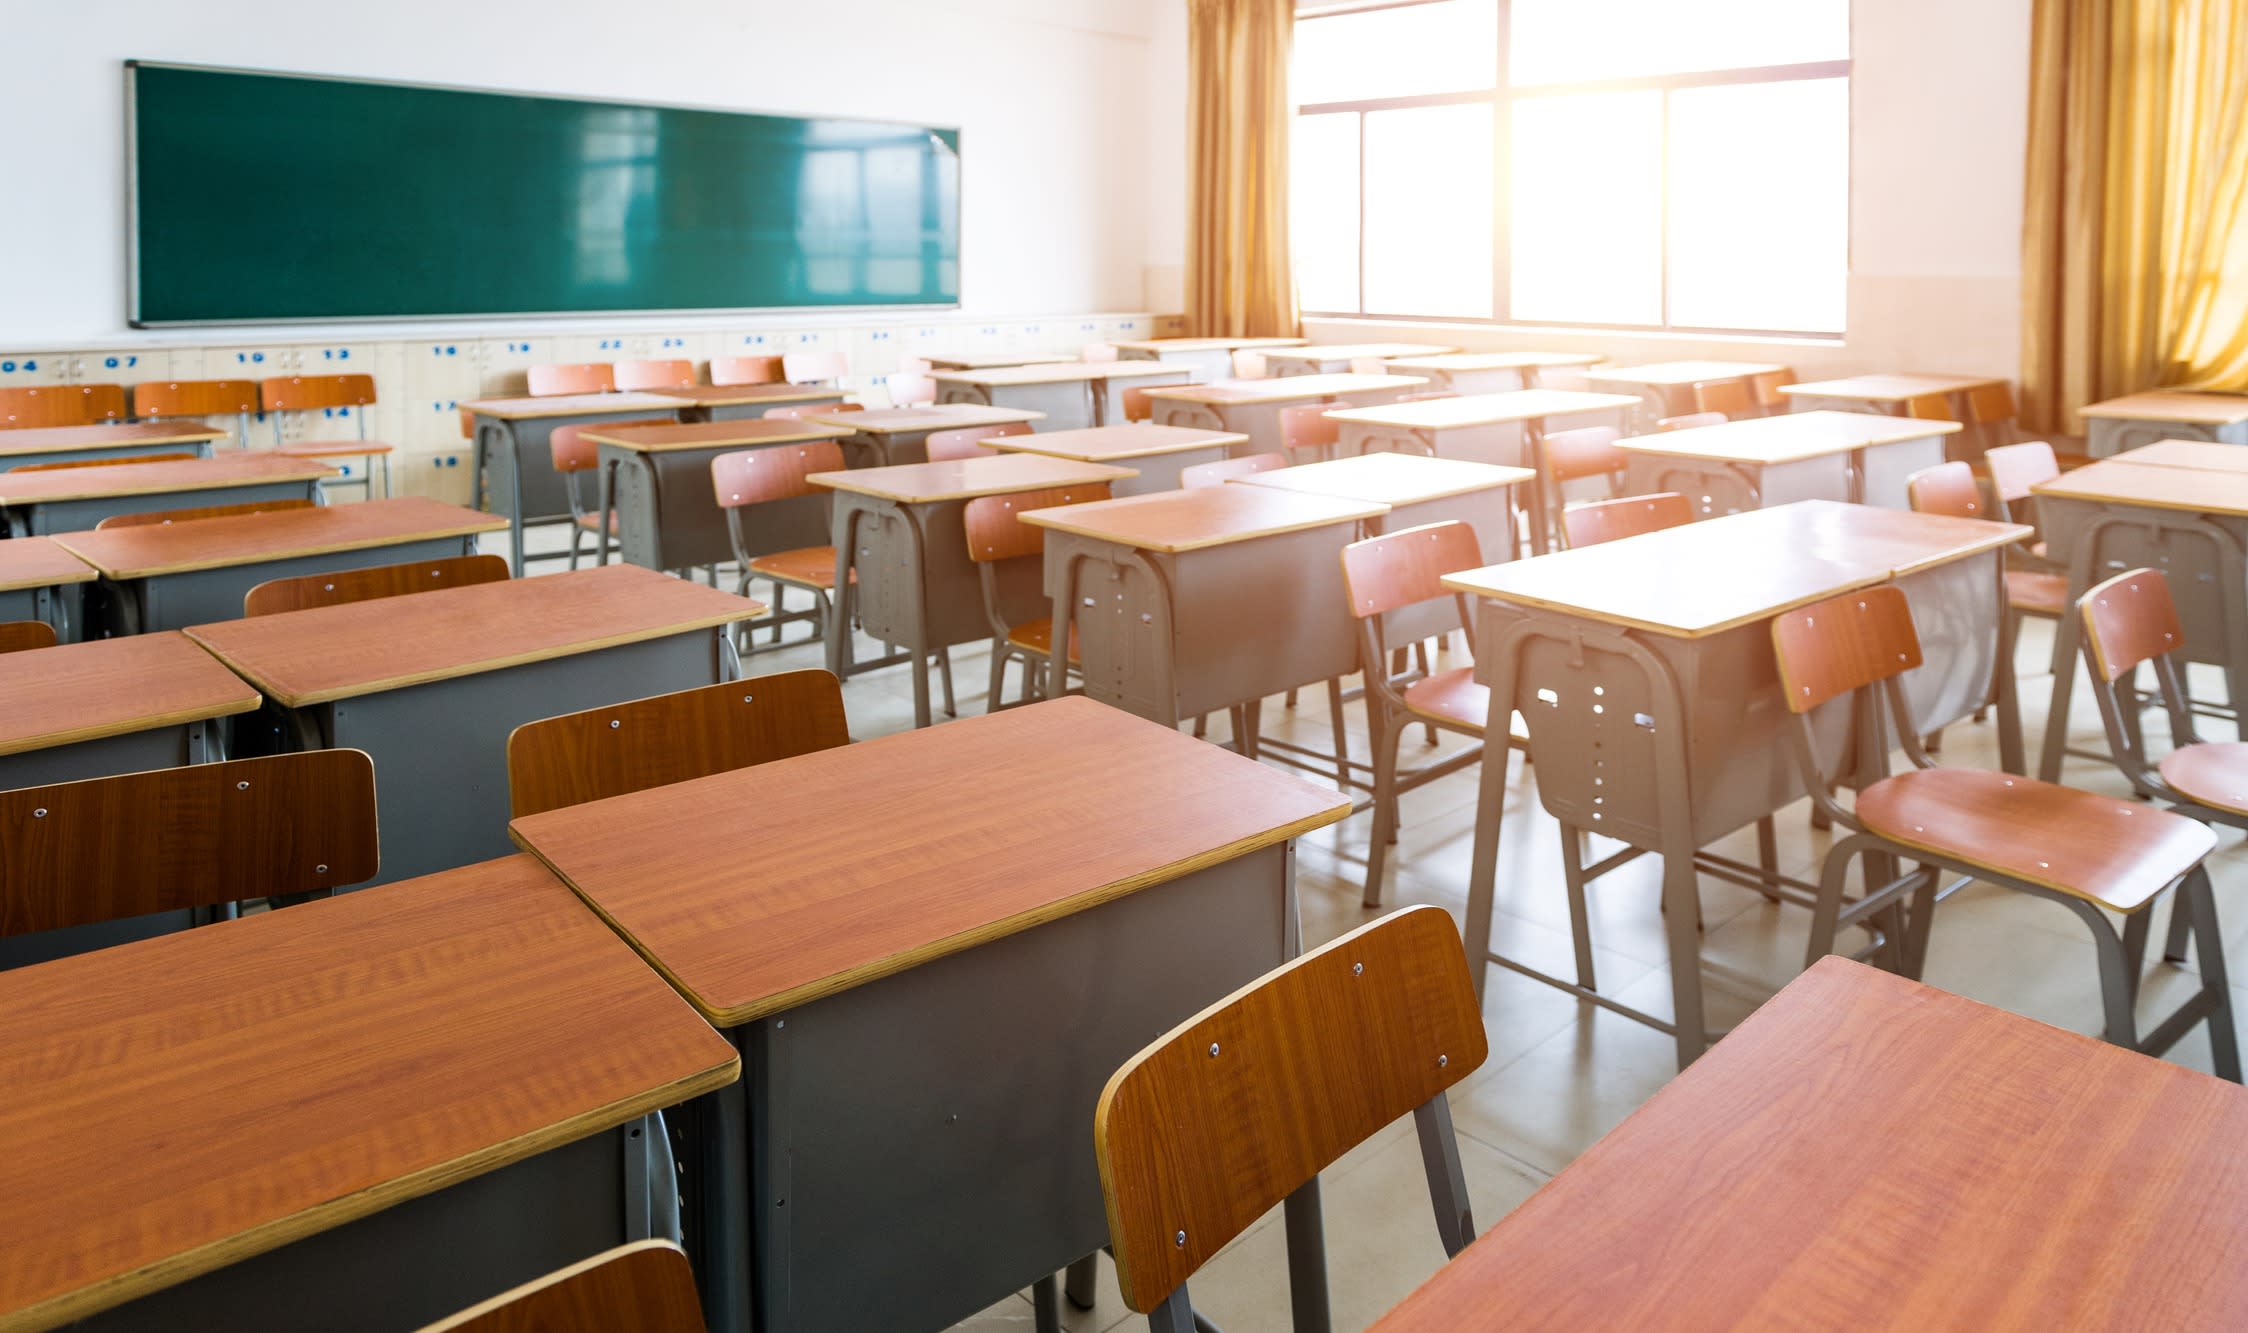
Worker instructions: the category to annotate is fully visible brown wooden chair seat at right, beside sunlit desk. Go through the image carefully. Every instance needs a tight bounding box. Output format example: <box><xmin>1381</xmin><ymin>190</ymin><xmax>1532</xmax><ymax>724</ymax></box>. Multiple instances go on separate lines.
<box><xmin>1857</xmin><ymin>769</ymin><xmax>2217</xmax><ymax>913</ymax></box>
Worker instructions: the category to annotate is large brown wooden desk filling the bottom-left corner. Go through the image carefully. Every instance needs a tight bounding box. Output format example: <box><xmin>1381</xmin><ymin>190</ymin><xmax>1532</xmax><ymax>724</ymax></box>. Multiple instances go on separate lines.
<box><xmin>0</xmin><ymin>854</ymin><xmax>740</xmax><ymax>1329</ymax></box>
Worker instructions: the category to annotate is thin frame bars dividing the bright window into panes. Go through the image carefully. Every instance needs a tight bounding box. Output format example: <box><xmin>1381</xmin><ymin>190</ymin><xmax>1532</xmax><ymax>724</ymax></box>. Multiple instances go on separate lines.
<box><xmin>1290</xmin><ymin>0</ymin><xmax>1857</xmax><ymax>342</ymax></box>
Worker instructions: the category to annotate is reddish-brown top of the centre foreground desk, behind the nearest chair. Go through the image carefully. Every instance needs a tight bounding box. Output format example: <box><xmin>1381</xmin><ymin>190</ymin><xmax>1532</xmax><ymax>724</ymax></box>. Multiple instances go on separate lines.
<box><xmin>514</xmin><ymin>697</ymin><xmax>1349</xmax><ymax>1027</ymax></box>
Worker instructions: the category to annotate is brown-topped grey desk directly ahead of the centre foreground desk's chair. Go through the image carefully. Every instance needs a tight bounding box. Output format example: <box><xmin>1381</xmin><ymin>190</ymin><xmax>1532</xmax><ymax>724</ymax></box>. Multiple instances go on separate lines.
<box><xmin>187</xmin><ymin>564</ymin><xmax>764</xmax><ymax>883</ymax></box>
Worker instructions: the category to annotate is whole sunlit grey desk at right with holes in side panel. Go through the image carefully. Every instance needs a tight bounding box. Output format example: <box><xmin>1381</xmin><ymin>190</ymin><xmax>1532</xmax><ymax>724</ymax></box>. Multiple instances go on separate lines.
<box><xmin>1443</xmin><ymin>501</ymin><xmax>2030</xmax><ymax>1068</ymax></box>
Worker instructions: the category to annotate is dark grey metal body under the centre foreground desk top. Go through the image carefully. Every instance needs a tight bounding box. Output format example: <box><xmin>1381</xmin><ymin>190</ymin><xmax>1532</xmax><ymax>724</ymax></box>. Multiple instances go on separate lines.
<box><xmin>681</xmin><ymin>843</ymin><xmax>1297</xmax><ymax>1333</ymax></box>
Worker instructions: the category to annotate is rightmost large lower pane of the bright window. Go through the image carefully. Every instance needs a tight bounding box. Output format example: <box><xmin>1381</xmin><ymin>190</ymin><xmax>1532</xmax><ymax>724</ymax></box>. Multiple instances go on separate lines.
<box><xmin>1670</xmin><ymin>79</ymin><xmax>1850</xmax><ymax>333</ymax></box>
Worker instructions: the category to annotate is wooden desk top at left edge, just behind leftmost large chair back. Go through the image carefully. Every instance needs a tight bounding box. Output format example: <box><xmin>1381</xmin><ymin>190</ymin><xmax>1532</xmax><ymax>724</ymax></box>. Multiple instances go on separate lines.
<box><xmin>0</xmin><ymin>632</ymin><xmax>259</xmax><ymax>755</ymax></box>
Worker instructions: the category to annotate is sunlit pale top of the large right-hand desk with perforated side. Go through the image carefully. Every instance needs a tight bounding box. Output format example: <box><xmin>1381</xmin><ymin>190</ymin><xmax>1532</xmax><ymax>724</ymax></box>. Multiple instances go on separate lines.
<box><xmin>1443</xmin><ymin>499</ymin><xmax>2030</xmax><ymax>638</ymax></box>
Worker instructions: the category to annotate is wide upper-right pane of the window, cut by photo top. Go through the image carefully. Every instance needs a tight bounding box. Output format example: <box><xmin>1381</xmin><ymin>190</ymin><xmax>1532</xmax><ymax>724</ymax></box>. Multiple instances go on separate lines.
<box><xmin>1510</xmin><ymin>0</ymin><xmax>1850</xmax><ymax>85</ymax></box>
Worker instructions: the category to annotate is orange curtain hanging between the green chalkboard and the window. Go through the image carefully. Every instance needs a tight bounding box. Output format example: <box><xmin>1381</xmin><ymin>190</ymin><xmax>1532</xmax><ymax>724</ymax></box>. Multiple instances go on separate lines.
<box><xmin>1187</xmin><ymin>0</ymin><xmax>1297</xmax><ymax>337</ymax></box>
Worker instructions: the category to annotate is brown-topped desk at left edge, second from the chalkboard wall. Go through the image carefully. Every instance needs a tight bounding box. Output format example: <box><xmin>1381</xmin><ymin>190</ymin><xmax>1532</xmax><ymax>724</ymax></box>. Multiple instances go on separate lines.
<box><xmin>0</xmin><ymin>452</ymin><xmax>339</xmax><ymax>537</ymax></box>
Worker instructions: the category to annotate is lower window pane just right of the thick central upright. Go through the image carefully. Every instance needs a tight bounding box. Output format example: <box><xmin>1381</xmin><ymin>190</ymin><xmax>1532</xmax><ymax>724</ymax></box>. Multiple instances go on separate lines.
<box><xmin>1508</xmin><ymin>92</ymin><xmax>1663</xmax><ymax>324</ymax></box>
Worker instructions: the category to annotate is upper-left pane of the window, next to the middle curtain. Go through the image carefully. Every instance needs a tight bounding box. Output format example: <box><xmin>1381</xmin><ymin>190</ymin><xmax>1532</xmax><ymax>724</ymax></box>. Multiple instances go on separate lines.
<box><xmin>1290</xmin><ymin>0</ymin><xmax>1499</xmax><ymax>106</ymax></box>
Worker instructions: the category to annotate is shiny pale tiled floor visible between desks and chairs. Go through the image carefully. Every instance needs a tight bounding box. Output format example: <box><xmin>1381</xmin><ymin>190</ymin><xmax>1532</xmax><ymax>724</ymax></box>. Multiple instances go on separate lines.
<box><xmin>501</xmin><ymin>526</ymin><xmax>2248</xmax><ymax>1333</ymax></box>
